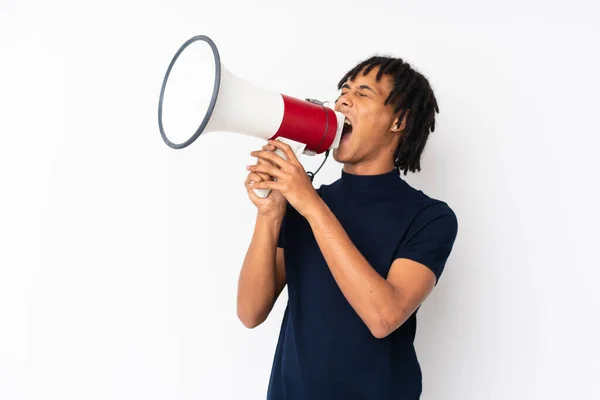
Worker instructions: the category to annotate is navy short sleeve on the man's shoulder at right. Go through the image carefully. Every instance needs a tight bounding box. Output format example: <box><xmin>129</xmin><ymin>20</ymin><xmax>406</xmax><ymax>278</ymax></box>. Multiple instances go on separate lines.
<box><xmin>394</xmin><ymin>203</ymin><xmax>458</xmax><ymax>285</ymax></box>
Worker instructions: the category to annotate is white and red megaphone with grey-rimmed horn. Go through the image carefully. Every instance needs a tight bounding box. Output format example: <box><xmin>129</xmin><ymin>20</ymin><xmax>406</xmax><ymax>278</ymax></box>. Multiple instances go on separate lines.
<box><xmin>158</xmin><ymin>35</ymin><xmax>345</xmax><ymax>197</ymax></box>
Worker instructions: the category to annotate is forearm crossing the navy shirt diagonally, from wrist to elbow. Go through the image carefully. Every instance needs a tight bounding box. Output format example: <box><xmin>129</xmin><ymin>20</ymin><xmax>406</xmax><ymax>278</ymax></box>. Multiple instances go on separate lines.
<box><xmin>307</xmin><ymin>201</ymin><xmax>399</xmax><ymax>337</ymax></box>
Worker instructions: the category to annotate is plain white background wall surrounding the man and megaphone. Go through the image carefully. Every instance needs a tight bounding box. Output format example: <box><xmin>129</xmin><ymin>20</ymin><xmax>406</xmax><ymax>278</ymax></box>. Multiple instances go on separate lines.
<box><xmin>0</xmin><ymin>0</ymin><xmax>600</xmax><ymax>400</ymax></box>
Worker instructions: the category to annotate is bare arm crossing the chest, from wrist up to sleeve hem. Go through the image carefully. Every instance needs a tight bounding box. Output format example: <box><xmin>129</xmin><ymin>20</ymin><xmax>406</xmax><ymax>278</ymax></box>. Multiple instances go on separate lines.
<box><xmin>307</xmin><ymin>202</ymin><xmax>436</xmax><ymax>338</ymax></box>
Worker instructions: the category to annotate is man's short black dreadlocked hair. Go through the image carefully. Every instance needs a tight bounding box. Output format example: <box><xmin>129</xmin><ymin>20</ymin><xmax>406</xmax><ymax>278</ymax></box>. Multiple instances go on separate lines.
<box><xmin>338</xmin><ymin>56</ymin><xmax>440</xmax><ymax>175</ymax></box>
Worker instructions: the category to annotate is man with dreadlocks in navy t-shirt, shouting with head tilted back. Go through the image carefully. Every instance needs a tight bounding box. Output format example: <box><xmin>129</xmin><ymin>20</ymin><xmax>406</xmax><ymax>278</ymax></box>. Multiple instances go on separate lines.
<box><xmin>237</xmin><ymin>57</ymin><xmax>458</xmax><ymax>400</ymax></box>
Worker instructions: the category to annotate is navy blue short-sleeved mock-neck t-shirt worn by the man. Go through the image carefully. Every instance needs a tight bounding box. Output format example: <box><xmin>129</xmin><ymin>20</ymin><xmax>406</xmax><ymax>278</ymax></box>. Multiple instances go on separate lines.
<box><xmin>267</xmin><ymin>169</ymin><xmax>458</xmax><ymax>400</ymax></box>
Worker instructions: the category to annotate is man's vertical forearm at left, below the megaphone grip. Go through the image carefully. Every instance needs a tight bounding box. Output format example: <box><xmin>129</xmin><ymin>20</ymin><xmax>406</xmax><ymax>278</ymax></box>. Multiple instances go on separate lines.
<box><xmin>237</xmin><ymin>216</ymin><xmax>281</xmax><ymax>326</ymax></box>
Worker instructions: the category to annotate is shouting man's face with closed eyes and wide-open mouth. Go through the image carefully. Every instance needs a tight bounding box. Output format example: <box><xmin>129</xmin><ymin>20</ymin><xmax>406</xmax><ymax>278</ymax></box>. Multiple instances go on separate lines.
<box><xmin>333</xmin><ymin>68</ymin><xmax>403</xmax><ymax>169</ymax></box>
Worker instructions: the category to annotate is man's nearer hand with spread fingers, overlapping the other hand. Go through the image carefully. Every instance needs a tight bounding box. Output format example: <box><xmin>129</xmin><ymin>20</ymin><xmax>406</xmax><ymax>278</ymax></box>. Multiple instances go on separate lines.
<box><xmin>246</xmin><ymin>140</ymin><xmax>321</xmax><ymax>217</ymax></box>
